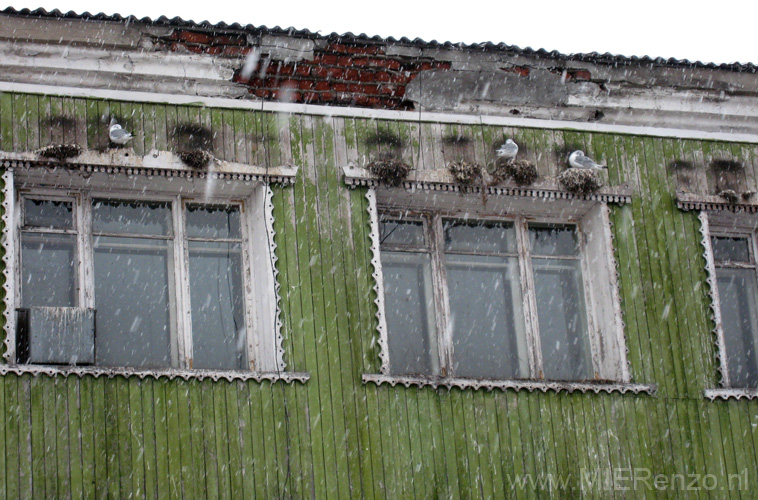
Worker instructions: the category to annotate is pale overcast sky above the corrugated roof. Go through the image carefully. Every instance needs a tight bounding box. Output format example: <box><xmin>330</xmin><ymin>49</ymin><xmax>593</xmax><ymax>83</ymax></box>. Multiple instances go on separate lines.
<box><xmin>5</xmin><ymin>0</ymin><xmax>758</xmax><ymax>63</ymax></box>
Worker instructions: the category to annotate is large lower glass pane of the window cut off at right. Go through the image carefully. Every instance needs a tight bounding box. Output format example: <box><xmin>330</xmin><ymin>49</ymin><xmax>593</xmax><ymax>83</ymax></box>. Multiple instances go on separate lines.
<box><xmin>716</xmin><ymin>268</ymin><xmax>758</xmax><ymax>388</ymax></box>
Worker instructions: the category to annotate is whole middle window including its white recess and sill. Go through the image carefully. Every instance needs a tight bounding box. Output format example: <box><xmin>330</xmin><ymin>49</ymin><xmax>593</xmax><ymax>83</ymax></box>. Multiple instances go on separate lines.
<box><xmin>363</xmin><ymin>190</ymin><xmax>632</xmax><ymax>392</ymax></box>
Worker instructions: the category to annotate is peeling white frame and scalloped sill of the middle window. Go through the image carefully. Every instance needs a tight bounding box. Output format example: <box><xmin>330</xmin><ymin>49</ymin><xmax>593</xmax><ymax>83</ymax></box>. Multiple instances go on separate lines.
<box><xmin>363</xmin><ymin>186</ymin><xmax>655</xmax><ymax>393</ymax></box>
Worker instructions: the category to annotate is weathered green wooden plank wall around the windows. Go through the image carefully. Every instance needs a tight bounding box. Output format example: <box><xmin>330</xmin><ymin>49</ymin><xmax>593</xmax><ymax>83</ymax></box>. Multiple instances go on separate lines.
<box><xmin>0</xmin><ymin>93</ymin><xmax>758</xmax><ymax>499</ymax></box>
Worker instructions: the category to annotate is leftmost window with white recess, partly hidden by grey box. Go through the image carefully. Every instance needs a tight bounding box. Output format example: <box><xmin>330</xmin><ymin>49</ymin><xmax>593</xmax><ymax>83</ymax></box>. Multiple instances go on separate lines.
<box><xmin>6</xmin><ymin>162</ymin><xmax>297</xmax><ymax>375</ymax></box>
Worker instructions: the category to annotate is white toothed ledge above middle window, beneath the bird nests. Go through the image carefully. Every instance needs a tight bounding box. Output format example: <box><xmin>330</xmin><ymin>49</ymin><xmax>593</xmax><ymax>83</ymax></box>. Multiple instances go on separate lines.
<box><xmin>342</xmin><ymin>163</ymin><xmax>632</xmax><ymax>205</ymax></box>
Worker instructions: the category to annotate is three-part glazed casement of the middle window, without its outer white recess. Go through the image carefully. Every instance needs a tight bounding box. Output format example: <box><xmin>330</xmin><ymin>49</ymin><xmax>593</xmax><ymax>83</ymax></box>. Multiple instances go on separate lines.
<box><xmin>379</xmin><ymin>213</ymin><xmax>593</xmax><ymax>380</ymax></box>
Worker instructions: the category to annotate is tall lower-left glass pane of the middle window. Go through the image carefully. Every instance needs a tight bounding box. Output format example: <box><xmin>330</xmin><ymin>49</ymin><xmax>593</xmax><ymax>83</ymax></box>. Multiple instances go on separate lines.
<box><xmin>382</xmin><ymin>252</ymin><xmax>439</xmax><ymax>375</ymax></box>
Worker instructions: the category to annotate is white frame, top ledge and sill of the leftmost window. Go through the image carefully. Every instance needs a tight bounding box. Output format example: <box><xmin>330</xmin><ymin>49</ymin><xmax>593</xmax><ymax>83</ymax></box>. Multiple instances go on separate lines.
<box><xmin>0</xmin><ymin>156</ymin><xmax>308</xmax><ymax>381</ymax></box>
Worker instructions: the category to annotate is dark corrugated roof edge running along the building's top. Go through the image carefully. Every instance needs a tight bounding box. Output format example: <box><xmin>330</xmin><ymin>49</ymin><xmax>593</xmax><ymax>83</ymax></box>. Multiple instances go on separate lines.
<box><xmin>0</xmin><ymin>7</ymin><xmax>758</xmax><ymax>73</ymax></box>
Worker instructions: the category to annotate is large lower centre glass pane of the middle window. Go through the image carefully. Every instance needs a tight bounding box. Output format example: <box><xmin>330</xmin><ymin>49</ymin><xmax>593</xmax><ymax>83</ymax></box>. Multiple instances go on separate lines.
<box><xmin>446</xmin><ymin>255</ymin><xmax>529</xmax><ymax>379</ymax></box>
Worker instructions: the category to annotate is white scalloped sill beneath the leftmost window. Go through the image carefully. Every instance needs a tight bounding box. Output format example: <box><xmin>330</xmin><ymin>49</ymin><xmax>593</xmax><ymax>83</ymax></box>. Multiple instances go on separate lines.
<box><xmin>0</xmin><ymin>364</ymin><xmax>310</xmax><ymax>383</ymax></box>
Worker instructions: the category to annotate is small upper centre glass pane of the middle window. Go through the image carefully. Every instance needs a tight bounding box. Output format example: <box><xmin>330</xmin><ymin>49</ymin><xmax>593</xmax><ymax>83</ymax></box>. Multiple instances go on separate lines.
<box><xmin>444</xmin><ymin>221</ymin><xmax>516</xmax><ymax>253</ymax></box>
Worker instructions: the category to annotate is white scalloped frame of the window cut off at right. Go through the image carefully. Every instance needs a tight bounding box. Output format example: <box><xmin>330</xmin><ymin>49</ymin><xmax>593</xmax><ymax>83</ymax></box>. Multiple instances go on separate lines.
<box><xmin>698</xmin><ymin>210</ymin><xmax>758</xmax><ymax>400</ymax></box>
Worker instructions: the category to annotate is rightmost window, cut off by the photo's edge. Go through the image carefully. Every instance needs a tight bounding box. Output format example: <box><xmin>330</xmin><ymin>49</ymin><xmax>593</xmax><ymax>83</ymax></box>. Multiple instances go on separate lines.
<box><xmin>701</xmin><ymin>212</ymin><xmax>758</xmax><ymax>395</ymax></box>
